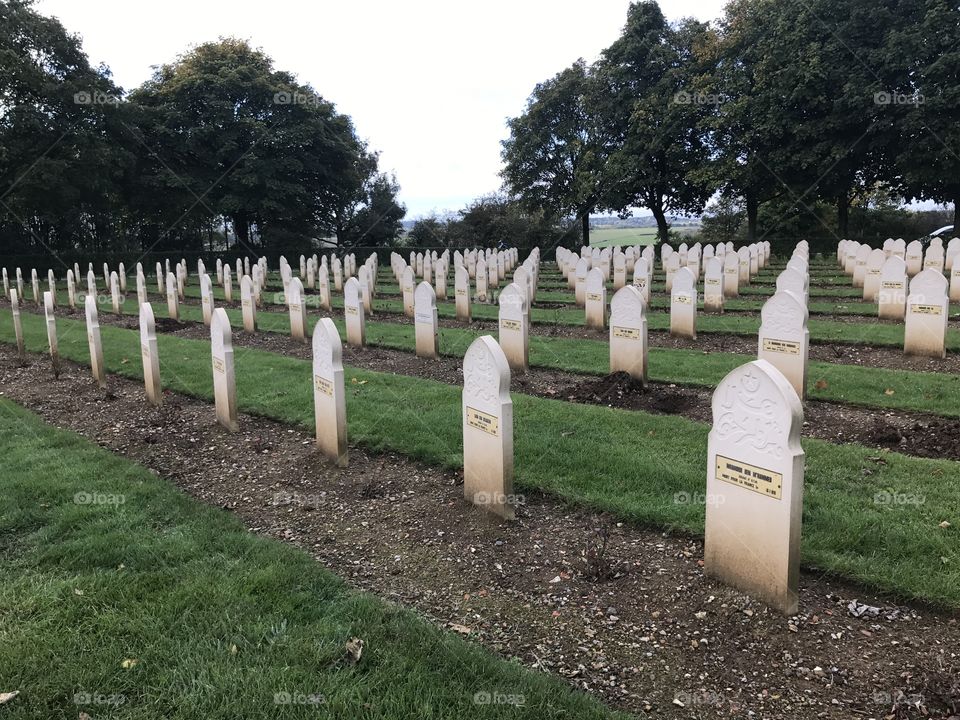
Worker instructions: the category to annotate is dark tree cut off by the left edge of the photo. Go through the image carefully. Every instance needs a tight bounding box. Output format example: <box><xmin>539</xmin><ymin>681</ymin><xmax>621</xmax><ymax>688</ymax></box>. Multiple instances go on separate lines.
<box><xmin>0</xmin><ymin>0</ymin><xmax>133</xmax><ymax>254</ymax></box>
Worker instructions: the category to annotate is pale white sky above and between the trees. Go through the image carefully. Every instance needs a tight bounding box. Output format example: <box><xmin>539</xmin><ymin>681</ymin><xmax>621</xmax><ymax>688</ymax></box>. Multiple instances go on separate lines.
<box><xmin>35</xmin><ymin>0</ymin><xmax>724</xmax><ymax>217</ymax></box>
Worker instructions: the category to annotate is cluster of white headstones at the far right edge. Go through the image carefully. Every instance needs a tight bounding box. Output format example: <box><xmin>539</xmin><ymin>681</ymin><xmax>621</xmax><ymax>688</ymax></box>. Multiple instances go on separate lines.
<box><xmin>837</xmin><ymin>238</ymin><xmax>960</xmax><ymax>358</ymax></box>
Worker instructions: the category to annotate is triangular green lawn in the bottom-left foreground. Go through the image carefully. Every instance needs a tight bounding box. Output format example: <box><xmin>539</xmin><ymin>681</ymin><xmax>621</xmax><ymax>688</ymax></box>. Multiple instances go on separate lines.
<box><xmin>0</xmin><ymin>399</ymin><xmax>619</xmax><ymax>720</ymax></box>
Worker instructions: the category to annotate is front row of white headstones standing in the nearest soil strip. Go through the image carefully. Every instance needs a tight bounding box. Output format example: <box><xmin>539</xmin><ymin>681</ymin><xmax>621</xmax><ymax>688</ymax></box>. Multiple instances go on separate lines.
<box><xmin>20</xmin><ymin>262</ymin><xmax>804</xmax><ymax>614</ymax></box>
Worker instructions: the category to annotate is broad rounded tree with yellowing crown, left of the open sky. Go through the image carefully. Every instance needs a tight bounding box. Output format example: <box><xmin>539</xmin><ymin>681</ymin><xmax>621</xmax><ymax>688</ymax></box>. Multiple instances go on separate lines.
<box><xmin>131</xmin><ymin>38</ymin><xmax>365</xmax><ymax>249</ymax></box>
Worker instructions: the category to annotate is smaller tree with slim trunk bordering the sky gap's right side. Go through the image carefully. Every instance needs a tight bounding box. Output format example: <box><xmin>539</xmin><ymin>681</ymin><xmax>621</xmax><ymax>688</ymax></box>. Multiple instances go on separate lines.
<box><xmin>501</xmin><ymin>59</ymin><xmax>608</xmax><ymax>244</ymax></box>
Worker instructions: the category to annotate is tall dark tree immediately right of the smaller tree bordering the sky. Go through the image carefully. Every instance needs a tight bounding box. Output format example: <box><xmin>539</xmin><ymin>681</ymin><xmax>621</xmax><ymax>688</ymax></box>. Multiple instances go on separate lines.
<box><xmin>596</xmin><ymin>0</ymin><xmax>711</xmax><ymax>241</ymax></box>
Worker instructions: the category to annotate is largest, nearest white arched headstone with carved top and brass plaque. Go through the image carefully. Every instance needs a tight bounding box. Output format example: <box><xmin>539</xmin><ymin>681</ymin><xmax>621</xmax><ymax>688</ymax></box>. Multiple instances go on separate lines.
<box><xmin>704</xmin><ymin>360</ymin><xmax>804</xmax><ymax>615</ymax></box>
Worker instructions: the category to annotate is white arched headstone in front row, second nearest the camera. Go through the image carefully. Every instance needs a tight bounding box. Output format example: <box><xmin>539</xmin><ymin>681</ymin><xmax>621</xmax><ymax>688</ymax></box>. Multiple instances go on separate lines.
<box><xmin>462</xmin><ymin>335</ymin><xmax>516</xmax><ymax>520</ymax></box>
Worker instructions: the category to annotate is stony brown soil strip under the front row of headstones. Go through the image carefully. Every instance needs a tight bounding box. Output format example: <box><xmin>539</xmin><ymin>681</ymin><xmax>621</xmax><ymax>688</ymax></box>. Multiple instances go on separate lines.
<box><xmin>0</xmin><ymin>346</ymin><xmax>960</xmax><ymax>720</ymax></box>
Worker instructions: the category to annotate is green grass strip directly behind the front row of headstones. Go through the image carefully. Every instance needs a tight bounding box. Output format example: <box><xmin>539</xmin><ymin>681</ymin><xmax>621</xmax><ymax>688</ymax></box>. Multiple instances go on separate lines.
<box><xmin>0</xmin><ymin>316</ymin><xmax>960</xmax><ymax>607</ymax></box>
